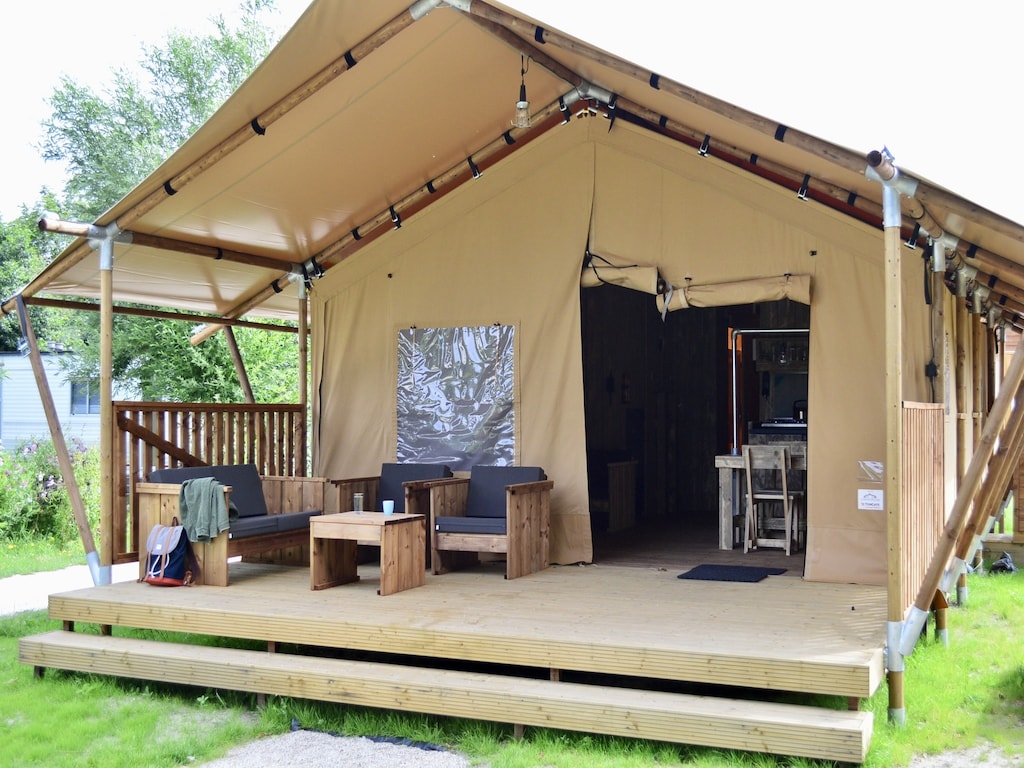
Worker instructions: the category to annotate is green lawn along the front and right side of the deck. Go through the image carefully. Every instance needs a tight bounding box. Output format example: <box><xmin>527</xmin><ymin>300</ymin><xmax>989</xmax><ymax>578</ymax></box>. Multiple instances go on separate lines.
<box><xmin>0</xmin><ymin>572</ymin><xmax>1024</xmax><ymax>768</ymax></box>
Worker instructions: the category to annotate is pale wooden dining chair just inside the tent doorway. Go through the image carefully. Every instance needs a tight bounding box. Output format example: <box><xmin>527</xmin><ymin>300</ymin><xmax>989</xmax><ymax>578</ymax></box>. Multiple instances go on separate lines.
<box><xmin>743</xmin><ymin>444</ymin><xmax>804</xmax><ymax>555</ymax></box>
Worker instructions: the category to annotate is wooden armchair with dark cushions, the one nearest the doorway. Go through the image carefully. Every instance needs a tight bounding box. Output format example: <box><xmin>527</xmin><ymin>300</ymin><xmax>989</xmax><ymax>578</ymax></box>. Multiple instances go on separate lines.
<box><xmin>429</xmin><ymin>466</ymin><xmax>554</xmax><ymax>579</ymax></box>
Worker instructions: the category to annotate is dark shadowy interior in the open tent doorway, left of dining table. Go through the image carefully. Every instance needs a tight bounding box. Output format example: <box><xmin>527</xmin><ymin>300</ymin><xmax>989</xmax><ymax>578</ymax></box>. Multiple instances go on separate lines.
<box><xmin>581</xmin><ymin>286</ymin><xmax>808</xmax><ymax>560</ymax></box>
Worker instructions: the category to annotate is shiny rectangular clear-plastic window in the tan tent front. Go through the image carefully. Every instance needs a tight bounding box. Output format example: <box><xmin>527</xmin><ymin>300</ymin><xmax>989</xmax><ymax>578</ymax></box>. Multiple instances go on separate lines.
<box><xmin>397</xmin><ymin>325</ymin><xmax>516</xmax><ymax>470</ymax></box>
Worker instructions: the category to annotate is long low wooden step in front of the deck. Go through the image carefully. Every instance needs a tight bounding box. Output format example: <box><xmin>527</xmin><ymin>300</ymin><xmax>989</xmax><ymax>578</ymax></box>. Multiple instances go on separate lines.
<box><xmin>18</xmin><ymin>631</ymin><xmax>872</xmax><ymax>763</ymax></box>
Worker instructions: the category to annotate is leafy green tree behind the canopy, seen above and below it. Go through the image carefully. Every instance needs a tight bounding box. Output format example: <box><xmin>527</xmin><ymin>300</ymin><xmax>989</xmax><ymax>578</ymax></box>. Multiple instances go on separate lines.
<box><xmin>23</xmin><ymin>0</ymin><xmax>297</xmax><ymax>402</ymax></box>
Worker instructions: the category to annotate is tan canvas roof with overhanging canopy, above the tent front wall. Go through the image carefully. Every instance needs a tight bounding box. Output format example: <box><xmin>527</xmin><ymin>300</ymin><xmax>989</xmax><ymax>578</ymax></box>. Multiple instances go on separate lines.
<box><xmin>12</xmin><ymin>0</ymin><xmax>1024</xmax><ymax>319</ymax></box>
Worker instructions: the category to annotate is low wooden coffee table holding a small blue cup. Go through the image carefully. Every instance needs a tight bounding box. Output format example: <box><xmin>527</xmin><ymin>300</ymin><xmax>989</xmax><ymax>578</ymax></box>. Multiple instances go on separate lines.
<box><xmin>309</xmin><ymin>512</ymin><xmax>427</xmax><ymax>595</ymax></box>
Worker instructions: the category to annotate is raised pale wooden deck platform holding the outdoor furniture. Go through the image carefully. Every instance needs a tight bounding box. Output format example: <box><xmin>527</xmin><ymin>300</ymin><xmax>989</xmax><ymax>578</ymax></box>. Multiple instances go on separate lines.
<box><xmin>44</xmin><ymin>564</ymin><xmax>885</xmax><ymax>697</ymax></box>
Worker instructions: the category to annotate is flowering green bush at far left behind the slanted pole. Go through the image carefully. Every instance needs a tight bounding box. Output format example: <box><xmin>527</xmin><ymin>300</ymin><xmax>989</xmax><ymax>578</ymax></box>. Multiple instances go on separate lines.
<box><xmin>0</xmin><ymin>438</ymin><xmax>99</xmax><ymax>542</ymax></box>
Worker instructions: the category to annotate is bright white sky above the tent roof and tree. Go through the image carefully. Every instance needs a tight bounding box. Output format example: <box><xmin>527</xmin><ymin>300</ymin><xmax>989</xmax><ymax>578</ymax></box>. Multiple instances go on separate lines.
<box><xmin>0</xmin><ymin>0</ymin><xmax>1024</xmax><ymax>223</ymax></box>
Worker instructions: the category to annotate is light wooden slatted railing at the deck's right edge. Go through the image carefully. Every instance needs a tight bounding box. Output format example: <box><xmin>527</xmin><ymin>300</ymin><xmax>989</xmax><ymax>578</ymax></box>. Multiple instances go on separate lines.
<box><xmin>899</xmin><ymin>402</ymin><xmax>945</xmax><ymax>609</ymax></box>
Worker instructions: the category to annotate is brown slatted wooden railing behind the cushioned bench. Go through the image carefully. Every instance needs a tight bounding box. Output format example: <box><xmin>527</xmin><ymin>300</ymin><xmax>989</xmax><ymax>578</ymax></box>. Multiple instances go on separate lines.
<box><xmin>111</xmin><ymin>401</ymin><xmax>308</xmax><ymax>563</ymax></box>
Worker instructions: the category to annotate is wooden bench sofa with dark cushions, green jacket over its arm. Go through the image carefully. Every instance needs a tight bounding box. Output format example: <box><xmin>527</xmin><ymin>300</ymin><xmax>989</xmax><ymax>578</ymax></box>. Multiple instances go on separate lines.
<box><xmin>135</xmin><ymin>465</ymin><xmax>341</xmax><ymax>587</ymax></box>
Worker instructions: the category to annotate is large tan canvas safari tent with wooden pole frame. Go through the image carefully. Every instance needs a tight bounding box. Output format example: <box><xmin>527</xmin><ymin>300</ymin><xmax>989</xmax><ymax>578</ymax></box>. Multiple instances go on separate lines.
<box><xmin>12</xmin><ymin>0</ymin><xmax>1024</xmax><ymax>757</ymax></box>
